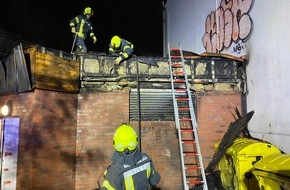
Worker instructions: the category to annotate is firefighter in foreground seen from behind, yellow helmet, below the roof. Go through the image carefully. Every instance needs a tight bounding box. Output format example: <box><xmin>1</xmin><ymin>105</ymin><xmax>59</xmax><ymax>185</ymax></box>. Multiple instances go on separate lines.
<box><xmin>101</xmin><ymin>124</ymin><xmax>160</xmax><ymax>190</ymax></box>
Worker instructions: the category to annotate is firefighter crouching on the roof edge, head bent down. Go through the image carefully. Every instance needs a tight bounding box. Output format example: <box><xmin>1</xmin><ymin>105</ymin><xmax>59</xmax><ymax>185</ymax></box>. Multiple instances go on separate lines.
<box><xmin>109</xmin><ymin>36</ymin><xmax>134</xmax><ymax>64</ymax></box>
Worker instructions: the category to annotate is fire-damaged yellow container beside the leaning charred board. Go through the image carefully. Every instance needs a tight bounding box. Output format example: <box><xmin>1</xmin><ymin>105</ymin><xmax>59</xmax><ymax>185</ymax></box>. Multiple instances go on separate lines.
<box><xmin>216</xmin><ymin>138</ymin><xmax>281</xmax><ymax>190</ymax></box>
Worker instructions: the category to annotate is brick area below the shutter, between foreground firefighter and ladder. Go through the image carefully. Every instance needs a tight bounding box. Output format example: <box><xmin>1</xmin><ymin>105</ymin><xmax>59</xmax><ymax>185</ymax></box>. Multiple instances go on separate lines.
<box><xmin>133</xmin><ymin>121</ymin><xmax>183</xmax><ymax>190</ymax></box>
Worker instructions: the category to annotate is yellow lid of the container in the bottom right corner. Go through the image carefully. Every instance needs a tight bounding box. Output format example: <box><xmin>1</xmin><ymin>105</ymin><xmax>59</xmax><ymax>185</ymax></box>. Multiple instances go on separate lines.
<box><xmin>254</xmin><ymin>154</ymin><xmax>290</xmax><ymax>177</ymax></box>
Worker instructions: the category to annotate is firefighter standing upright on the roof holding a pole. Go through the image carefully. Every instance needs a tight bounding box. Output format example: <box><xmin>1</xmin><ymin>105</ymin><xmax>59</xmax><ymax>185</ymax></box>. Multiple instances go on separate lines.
<box><xmin>69</xmin><ymin>7</ymin><xmax>97</xmax><ymax>53</ymax></box>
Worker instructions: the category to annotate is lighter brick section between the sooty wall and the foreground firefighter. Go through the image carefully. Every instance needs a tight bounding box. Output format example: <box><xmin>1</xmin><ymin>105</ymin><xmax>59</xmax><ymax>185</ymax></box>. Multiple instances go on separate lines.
<box><xmin>76</xmin><ymin>92</ymin><xmax>129</xmax><ymax>190</ymax></box>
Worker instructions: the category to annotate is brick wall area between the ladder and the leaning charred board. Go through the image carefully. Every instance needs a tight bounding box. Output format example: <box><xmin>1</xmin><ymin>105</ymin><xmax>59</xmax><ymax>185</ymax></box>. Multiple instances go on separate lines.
<box><xmin>197</xmin><ymin>91</ymin><xmax>242</xmax><ymax>167</ymax></box>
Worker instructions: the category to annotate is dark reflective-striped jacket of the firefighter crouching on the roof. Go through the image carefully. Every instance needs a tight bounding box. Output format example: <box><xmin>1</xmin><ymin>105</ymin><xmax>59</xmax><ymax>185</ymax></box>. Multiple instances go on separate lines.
<box><xmin>109</xmin><ymin>39</ymin><xmax>134</xmax><ymax>61</ymax></box>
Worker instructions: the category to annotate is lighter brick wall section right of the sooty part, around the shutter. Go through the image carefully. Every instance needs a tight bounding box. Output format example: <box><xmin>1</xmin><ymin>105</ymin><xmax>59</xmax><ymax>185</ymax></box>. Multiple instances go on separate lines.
<box><xmin>76</xmin><ymin>92</ymin><xmax>241</xmax><ymax>190</ymax></box>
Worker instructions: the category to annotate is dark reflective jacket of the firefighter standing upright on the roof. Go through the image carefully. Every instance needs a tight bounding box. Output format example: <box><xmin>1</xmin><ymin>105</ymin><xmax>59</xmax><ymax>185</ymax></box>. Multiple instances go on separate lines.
<box><xmin>69</xmin><ymin>15</ymin><xmax>95</xmax><ymax>40</ymax></box>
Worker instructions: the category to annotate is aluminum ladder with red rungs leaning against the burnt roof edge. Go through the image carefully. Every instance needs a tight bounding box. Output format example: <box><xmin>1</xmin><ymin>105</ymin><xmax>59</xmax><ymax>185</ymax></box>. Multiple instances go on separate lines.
<box><xmin>168</xmin><ymin>44</ymin><xmax>208</xmax><ymax>190</ymax></box>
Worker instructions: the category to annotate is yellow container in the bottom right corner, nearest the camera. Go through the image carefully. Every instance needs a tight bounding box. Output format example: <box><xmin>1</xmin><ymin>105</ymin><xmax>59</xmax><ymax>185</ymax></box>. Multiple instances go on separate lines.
<box><xmin>252</xmin><ymin>154</ymin><xmax>290</xmax><ymax>190</ymax></box>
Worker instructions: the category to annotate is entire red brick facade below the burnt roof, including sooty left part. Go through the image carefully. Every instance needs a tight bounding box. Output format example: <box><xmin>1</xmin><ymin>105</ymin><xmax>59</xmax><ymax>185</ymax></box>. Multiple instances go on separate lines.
<box><xmin>0</xmin><ymin>90</ymin><xmax>241</xmax><ymax>190</ymax></box>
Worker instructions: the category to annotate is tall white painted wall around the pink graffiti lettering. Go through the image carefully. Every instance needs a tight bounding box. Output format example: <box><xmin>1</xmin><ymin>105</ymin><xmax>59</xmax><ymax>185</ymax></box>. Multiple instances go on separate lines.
<box><xmin>164</xmin><ymin>0</ymin><xmax>290</xmax><ymax>153</ymax></box>
